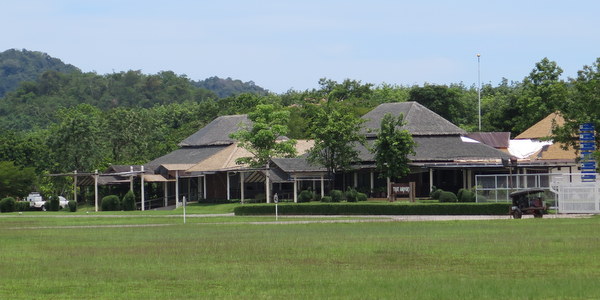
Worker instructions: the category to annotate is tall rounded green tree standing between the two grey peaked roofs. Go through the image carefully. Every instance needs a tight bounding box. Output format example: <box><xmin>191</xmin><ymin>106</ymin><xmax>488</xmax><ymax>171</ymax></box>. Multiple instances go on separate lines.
<box><xmin>308</xmin><ymin>101</ymin><xmax>365</xmax><ymax>190</ymax></box>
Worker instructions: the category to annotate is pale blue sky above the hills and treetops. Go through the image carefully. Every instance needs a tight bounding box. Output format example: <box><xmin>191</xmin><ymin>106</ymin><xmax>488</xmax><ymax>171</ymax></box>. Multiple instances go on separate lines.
<box><xmin>0</xmin><ymin>0</ymin><xmax>600</xmax><ymax>93</ymax></box>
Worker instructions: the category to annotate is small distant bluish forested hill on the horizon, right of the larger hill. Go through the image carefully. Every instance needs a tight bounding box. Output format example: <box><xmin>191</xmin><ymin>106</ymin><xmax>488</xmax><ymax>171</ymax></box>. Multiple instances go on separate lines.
<box><xmin>193</xmin><ymin>76</ymin><xmax>268</xmax><ymax>98</ymax></box>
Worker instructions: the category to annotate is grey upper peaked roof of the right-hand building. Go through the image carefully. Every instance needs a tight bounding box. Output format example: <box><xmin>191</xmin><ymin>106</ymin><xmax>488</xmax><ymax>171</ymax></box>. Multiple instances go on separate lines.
<box><xmin>362</xmin><ymin>102</ymin><xmax>466</xmax><ymax>137</ymax></box>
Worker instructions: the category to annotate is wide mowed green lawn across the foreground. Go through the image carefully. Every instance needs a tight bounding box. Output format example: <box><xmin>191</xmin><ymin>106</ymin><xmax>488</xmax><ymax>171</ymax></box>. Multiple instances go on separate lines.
<box><xmin>0</xmin><ymin>217</ymin><xmax>600</xmax><ymax>299</ymax></box>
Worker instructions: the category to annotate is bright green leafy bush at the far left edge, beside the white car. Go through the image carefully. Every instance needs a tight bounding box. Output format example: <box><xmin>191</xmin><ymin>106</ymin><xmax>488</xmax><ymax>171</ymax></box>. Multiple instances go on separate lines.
<box><xmin>0</xmin><ymin>161</ymin><xmax>36</xmax><ymax>198</ymax></box>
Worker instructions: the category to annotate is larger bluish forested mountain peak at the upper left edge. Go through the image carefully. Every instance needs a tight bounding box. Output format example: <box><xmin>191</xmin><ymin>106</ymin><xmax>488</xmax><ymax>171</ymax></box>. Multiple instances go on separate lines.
<box><xmin>0</xmin><ymin>49</ymin><xmax>79</xmax><ymax>98</ymax></box>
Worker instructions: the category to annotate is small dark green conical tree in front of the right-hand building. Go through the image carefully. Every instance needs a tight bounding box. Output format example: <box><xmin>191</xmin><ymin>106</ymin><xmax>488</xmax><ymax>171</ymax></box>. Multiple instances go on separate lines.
<box><xmin>373</xmin><ymin>113</ymin><xmax>415</xmax><ymax>178</ymax></box>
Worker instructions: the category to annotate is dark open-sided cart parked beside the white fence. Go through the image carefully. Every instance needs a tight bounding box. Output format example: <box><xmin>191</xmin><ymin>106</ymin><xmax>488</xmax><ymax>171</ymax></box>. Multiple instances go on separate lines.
<box><xmin>509</xmin><ymin>189</ymin><xmax>547</xmax><ymax>219</ymax></box>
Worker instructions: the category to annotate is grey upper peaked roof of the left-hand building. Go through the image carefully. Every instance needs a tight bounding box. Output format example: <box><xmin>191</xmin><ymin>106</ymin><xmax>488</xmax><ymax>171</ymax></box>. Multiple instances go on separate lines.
<box><xmin>179</xmin><ymin>115</ymin><xmax>251</xmax><ymax>147</ymax></box>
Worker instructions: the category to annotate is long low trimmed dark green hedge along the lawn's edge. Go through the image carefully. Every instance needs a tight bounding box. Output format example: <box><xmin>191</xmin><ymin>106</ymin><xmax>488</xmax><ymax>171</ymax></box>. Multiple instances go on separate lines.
<box><xmin>234</xmin><ymin>203</ymin><xmax>510</xmax><ymax>216</ymax></box>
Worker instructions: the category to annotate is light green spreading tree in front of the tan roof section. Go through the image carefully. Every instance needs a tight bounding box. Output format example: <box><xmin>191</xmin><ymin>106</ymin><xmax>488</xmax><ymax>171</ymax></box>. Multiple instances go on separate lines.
<box><xmin>231</xmin><ymin>104</ymin><xmax>296</xmax><ymax>167</ymax></box>
